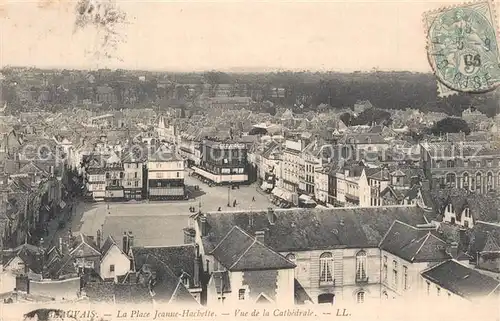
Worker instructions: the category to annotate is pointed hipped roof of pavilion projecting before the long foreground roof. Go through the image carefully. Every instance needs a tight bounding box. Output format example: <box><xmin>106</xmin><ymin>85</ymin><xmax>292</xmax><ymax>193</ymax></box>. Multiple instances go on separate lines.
<box><xmin>211</xmin><ymin>226</ymin><xmax>295</xmax><ymax>271</ymax></box>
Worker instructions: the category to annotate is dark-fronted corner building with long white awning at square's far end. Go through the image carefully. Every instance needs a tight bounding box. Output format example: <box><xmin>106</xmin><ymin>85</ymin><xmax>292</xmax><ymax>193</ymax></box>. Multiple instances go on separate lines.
<box><xmin>193</xmin><ymin>139</ymin><xmax>248</xmax><ymax>184</ymax></box>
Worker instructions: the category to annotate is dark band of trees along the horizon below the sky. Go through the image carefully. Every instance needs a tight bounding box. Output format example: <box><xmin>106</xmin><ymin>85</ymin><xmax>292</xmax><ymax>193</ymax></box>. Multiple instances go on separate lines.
<box><xmin>1</xmin><ymin>68</ymin><xmax>499</xmax><ymax>116</ymax></box>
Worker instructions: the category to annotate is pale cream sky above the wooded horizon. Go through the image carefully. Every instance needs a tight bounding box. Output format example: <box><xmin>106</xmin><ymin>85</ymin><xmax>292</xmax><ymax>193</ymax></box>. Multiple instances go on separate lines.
<box><xmin>0</xmin><ymin>0</ymin><xmax>498</xmax><ymax>72</ymax></box>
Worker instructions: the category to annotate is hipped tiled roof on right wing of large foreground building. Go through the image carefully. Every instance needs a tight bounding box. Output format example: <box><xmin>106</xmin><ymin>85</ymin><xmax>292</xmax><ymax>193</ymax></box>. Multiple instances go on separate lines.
<box><xmin>380</xmin><ymin>221</ymin><xmax>451</xmax><ymax>262</ymax></box>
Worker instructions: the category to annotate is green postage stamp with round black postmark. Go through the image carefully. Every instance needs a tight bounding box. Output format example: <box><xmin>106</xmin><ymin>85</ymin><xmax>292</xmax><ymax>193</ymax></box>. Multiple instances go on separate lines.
<box><xmin>424</xmin><ymin>1</ymin><xmax>500</xmax><ymax>96</ymax></box>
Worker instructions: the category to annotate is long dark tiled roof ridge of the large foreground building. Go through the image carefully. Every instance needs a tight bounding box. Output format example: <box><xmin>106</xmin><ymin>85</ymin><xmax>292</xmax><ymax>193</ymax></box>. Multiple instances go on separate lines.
<box><xmin>203</xmin><ymin>206</ymin><xmax>427</xmax><ymax>252</ymax></box>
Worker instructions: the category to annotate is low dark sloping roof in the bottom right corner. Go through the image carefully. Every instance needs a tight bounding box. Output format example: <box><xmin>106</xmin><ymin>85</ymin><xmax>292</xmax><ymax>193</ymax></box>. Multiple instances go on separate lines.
<box><xmin>422</xmin><ymin>260</ymin><xmax>500</xmax><ymax>300</ymax></box>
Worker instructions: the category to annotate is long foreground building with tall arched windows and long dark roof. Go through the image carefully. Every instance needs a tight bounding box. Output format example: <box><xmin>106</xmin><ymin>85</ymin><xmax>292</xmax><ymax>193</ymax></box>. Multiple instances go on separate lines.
<box><xmin>186</xmin><ymin>206</ymin><xmax>432</xmax><ymax>304</ymax></box>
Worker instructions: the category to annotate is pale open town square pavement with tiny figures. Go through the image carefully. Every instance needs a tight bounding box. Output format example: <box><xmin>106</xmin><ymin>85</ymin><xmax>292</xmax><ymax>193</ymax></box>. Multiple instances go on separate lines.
<box><xmin>71</xmin><ymin>171</ymin><xmax>275</xmax><ymax>246</ymax></box>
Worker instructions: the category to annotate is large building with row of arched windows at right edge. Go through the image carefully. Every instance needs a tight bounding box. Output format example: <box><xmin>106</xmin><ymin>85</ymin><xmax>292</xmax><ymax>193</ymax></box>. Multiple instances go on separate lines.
<box><xmin>421</xmin><ymin>142</ymin><xmax>500</xmax><ymax>194</ymax></box>
